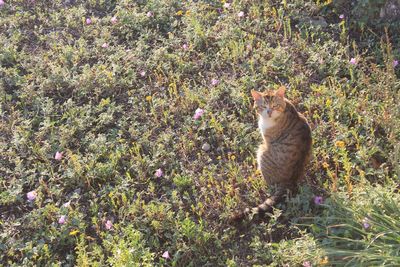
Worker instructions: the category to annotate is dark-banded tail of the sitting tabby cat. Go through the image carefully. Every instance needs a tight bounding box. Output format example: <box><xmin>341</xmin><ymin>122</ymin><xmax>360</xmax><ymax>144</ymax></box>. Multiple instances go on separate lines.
<box><xmin>230</xmin><ymin>190</ymin><xmax>286</xmax><ymax>222</ymax></box>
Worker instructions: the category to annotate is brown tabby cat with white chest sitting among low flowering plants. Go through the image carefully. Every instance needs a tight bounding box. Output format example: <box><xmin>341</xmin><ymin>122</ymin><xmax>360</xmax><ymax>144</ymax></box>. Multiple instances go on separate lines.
<box><xmin>233</xmin><ymin>86</ymin><xmax>312</xmax><ymax>220</ymax></box>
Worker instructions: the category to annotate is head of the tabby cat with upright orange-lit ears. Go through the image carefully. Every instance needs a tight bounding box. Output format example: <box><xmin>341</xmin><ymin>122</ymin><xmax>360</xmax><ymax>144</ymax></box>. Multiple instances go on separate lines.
<box><xmin>251</xmin><ymin>86</ymin><xmax>286</xmax><ymax>119</ymax></box>
